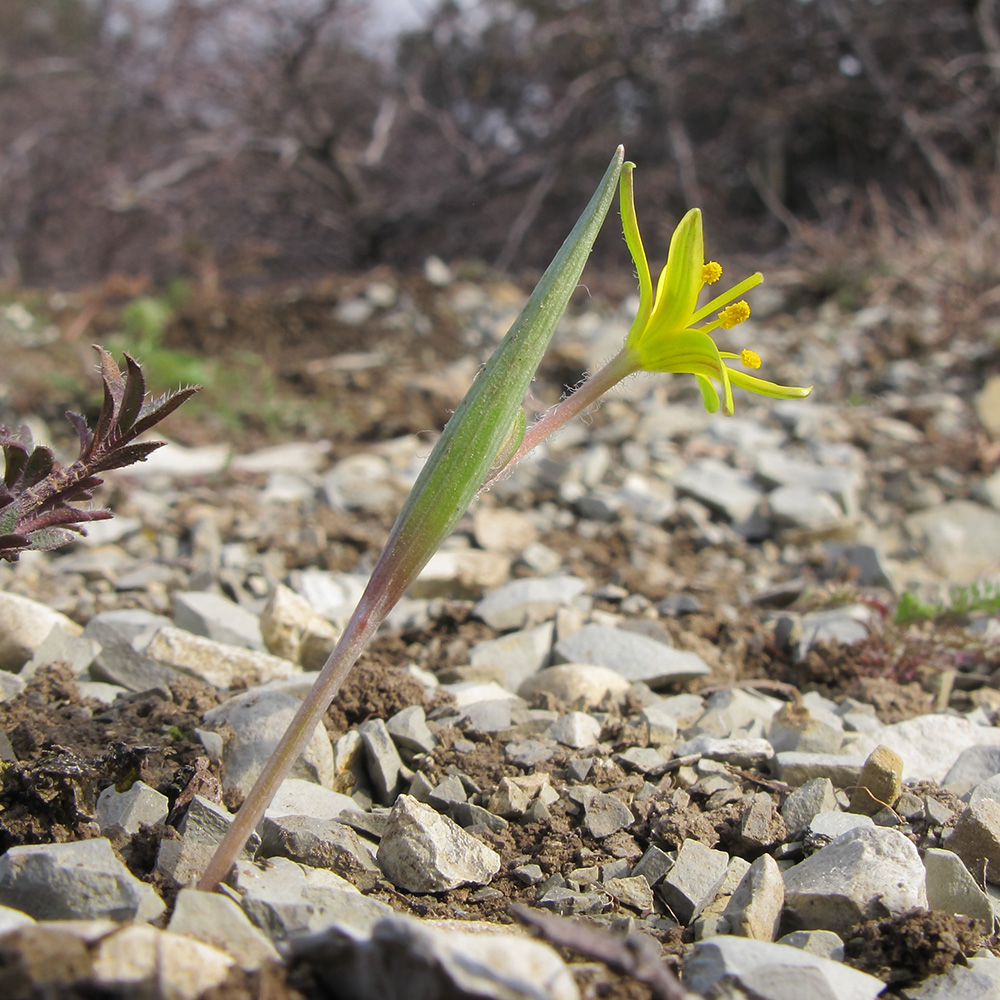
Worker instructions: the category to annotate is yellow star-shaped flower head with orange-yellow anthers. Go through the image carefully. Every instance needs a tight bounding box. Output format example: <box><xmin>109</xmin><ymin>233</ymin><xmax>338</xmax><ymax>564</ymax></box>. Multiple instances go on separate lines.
<box><xmin>621</xmin><ymin>163</ymin><xmax>812</xmax><ymax>415</ymax></box>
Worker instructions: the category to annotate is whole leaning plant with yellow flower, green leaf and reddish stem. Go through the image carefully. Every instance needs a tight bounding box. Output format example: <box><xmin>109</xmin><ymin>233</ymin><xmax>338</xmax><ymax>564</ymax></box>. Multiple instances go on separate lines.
<box><xmin>199</xmin><ymin>147</ymin><xmax>811</xmax><ymax>890</ymax></box>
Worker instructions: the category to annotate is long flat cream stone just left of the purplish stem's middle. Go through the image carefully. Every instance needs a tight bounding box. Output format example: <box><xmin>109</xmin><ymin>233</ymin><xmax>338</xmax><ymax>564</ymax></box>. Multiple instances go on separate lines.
<box><xmin>145</xmin><ymin>625</ymin><xmax>299</xmax><ymax>690</ymax></box>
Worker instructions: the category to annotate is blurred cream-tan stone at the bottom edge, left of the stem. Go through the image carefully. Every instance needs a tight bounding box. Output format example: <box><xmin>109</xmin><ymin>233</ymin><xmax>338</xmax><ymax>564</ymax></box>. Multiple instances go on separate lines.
<box><xmin>93</xmin><ymin>927</ymin><xmax>235</xmax><ymax>1000</ymax></box>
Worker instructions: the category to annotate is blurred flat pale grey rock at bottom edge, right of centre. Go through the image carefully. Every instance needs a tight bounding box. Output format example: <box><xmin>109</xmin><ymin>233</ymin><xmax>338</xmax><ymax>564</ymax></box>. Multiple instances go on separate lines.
<box><xmin>684</xmin><ymin>936</ymin><xmax>885</xmax><ymax>1000</ymax></box>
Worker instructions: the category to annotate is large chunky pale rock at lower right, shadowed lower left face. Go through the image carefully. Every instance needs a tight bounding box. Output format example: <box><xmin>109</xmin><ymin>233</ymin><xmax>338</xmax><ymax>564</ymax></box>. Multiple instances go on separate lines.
<box><xmin>785</xmin><ymin>827</ymin><xmax>927</xmax><ymax>935</ymax></box>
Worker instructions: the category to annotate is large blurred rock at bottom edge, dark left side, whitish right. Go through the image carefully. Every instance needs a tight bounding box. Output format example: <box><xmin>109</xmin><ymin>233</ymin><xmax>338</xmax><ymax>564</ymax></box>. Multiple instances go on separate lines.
<box><xmin>295</xmin><ymin>914</ymin><xmax>579</xmax><ymax>1000</ymax></box>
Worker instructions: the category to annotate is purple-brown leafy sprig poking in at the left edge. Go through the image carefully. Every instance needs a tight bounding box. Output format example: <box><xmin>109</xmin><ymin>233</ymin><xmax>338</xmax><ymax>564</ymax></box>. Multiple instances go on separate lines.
<box><xmin>0</xmin><ymin>345</ymin><xmax>201</xmax><ymax>562</ymax></box>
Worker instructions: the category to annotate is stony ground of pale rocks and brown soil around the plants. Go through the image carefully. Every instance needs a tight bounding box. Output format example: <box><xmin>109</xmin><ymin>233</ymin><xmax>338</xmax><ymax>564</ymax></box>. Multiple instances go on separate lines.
<box><xmin>0</xmin><ymin>240</ymin><xmax>1000</xmax><ymax>1000</ymax></box>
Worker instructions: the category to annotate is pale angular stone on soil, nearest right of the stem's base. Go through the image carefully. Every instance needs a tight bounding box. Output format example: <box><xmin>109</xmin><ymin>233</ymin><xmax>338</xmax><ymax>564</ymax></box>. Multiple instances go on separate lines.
<box><xmin>376</xmin><ymin>795</ymin><xmax>500</xmax><ymax>892</ymax></box>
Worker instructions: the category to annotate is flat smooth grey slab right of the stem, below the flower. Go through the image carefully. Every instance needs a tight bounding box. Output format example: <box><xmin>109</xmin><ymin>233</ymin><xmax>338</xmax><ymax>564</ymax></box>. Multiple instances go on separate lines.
<box><xmin>555</xmin><ymin>625</ymin><xmax>709</xmax><ymax>690</ymax></box>
